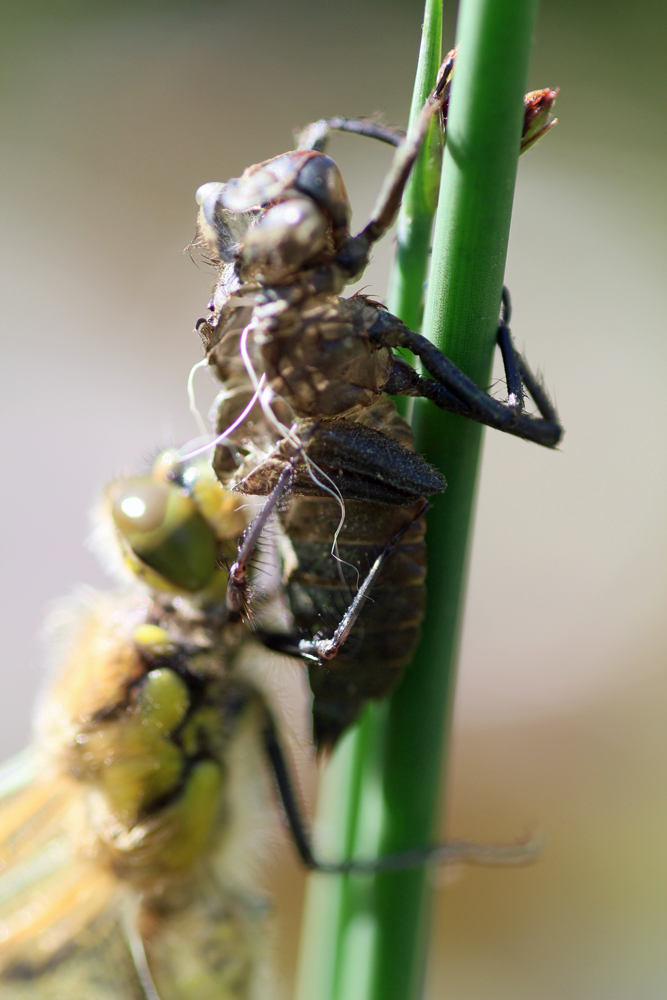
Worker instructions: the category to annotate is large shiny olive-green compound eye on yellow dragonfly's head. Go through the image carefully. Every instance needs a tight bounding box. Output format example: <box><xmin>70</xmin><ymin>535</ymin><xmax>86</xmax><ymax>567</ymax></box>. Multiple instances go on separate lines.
<box><xmin>109</xmin><ymin>476</ymin><xmax>218</xmax><ymax>593</ymax></box>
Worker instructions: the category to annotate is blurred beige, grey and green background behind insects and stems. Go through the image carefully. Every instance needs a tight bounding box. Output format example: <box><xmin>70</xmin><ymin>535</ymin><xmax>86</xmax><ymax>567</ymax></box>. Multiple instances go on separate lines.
<box><xmin>0</xmin><ymin>0</ymin><xmax>667</xmax><ymax>1000</ymax></box>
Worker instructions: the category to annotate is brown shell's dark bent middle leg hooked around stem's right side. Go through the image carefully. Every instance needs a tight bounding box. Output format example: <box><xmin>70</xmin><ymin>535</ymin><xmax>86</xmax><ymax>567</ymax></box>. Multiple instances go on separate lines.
<box><xmin>368</xmin><ymin>289</ymin><xmax>563</xmax><ymax>448</ymax></box>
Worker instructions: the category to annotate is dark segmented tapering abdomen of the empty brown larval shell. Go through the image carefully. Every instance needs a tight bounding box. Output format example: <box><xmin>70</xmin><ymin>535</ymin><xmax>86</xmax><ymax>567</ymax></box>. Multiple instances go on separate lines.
<box><xmin>283</xmin><ymin>497</ymin><xmax>426</xmax><ymax>748</ymax></box>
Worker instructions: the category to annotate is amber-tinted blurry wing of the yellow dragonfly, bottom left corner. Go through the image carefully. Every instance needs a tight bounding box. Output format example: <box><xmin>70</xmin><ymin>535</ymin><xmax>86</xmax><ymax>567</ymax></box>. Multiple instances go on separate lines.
<box><xmin>0</xmin><ymin>751</ymin><xmax>140</xmax><ymax>1000</ymax></box>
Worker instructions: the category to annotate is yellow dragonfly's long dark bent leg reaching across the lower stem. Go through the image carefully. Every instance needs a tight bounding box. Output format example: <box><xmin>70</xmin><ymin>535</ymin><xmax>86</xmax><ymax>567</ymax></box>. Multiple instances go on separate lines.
<box><xmin>262</xmin><ymin>705</ymin><xmax>541</xmax><ymax>875</ymax></box>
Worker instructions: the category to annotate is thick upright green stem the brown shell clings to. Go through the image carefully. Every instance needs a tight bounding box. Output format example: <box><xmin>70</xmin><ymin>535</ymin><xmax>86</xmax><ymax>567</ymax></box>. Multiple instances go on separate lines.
<box><xmin>297</xmin><ymin>0</ymin><xmax>536</xmax><ymax>1000</ymax></box>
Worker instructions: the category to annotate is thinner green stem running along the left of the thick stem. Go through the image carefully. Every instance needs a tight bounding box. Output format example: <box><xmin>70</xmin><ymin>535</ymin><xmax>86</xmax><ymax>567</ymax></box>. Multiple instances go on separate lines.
<box><xmin>296</xmin><ymin>7</ymin><xmax>442</xmax><ymax>1000</ymax></box>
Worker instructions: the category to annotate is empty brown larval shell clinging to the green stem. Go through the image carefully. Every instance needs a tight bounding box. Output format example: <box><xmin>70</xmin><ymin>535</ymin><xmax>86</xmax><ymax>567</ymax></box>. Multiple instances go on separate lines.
<box><xmin>197</xmin><ymin>53</ymin><xmax>562</xmax><ymax>746</ymax></box>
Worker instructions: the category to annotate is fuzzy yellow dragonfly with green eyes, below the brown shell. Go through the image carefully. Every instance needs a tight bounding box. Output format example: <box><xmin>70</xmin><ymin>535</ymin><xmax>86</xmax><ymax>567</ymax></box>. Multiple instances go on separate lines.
<box><xmin>0</xmin><ymin>451</ymin><xmax>531</xmax><ymax>1000</ymax></box>
